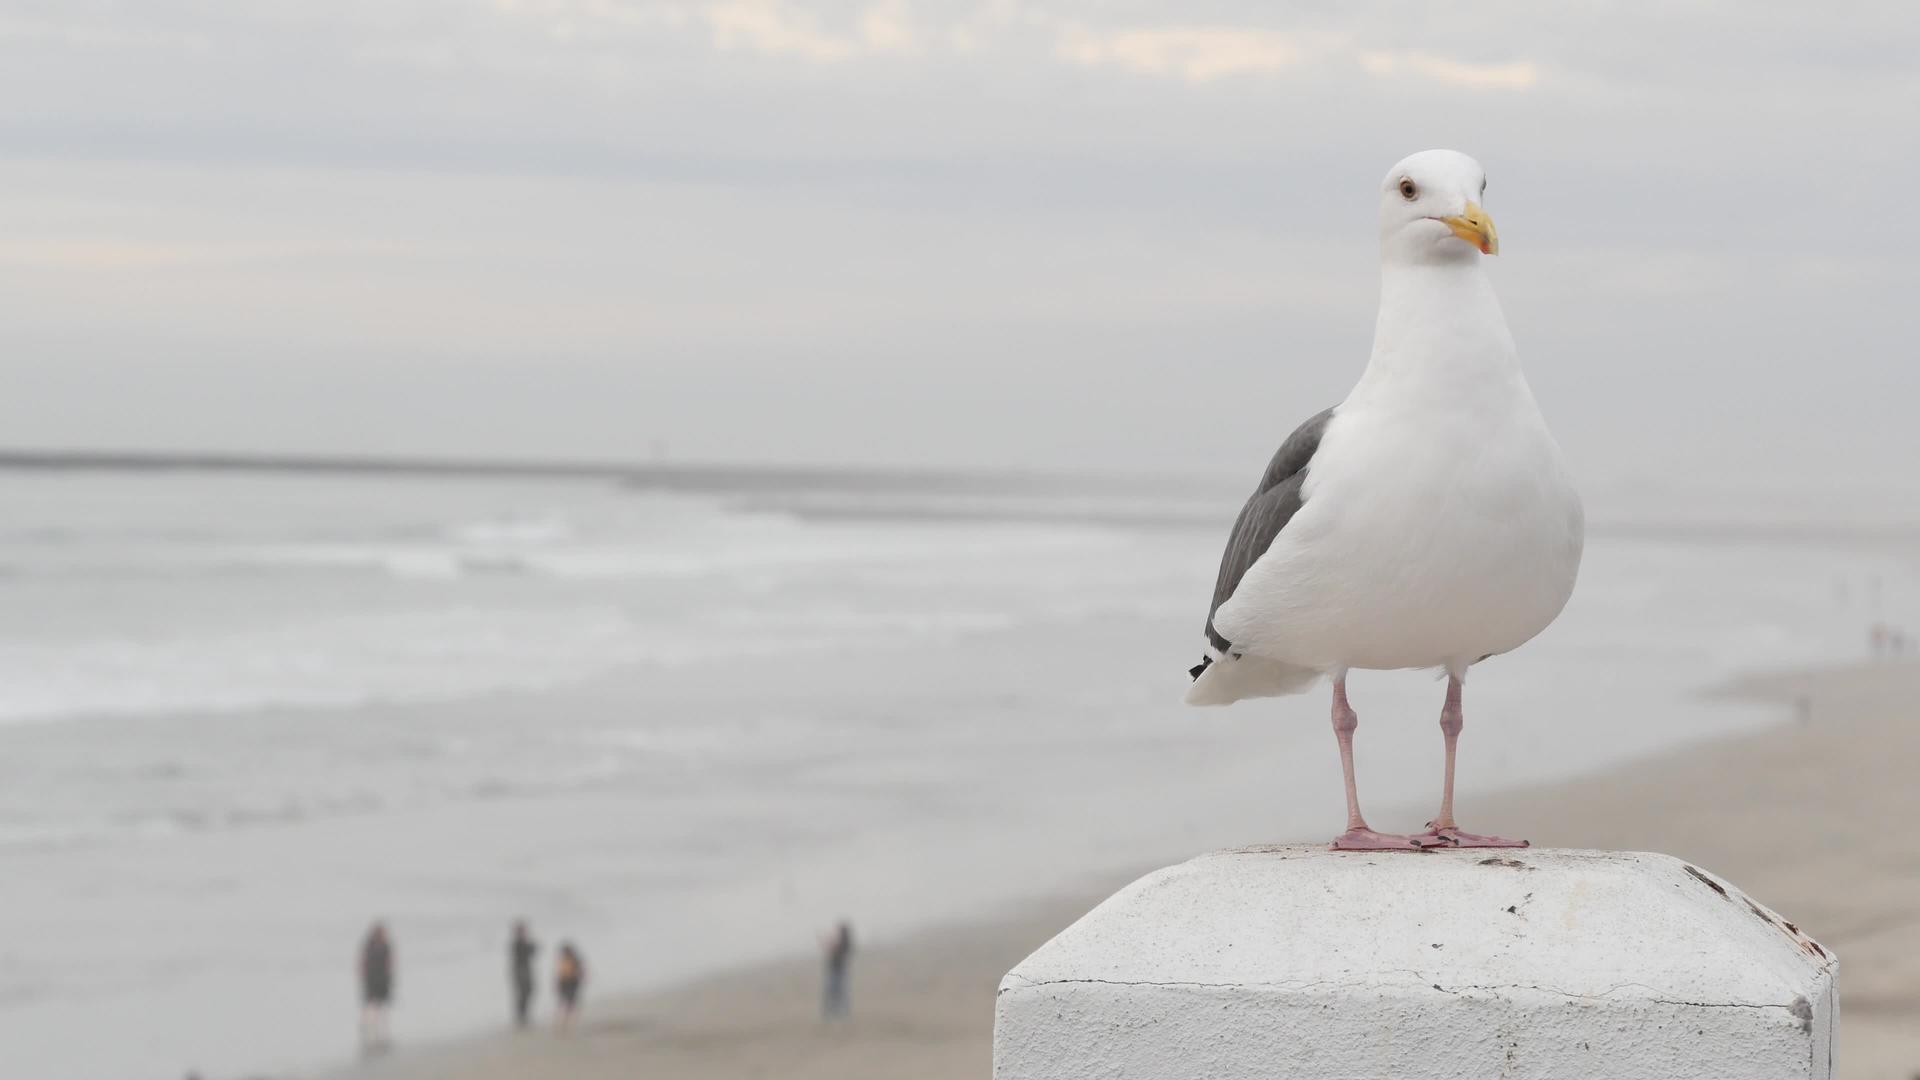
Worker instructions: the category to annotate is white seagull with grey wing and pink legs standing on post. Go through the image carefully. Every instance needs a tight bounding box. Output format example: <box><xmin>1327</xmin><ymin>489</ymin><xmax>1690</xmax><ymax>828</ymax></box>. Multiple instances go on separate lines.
<box><xmin>1187</xmin><ymin>150</ymin><xmax>1586</xmax><ymax>851</ymax></box>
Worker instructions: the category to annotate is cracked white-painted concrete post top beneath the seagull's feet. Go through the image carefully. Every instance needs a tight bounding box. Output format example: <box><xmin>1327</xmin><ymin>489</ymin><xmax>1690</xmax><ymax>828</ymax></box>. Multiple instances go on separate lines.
<box><xmin>993</xmin><ymin>847</ymin><xmax>1839</xmax><ymax>1080</ymax></box>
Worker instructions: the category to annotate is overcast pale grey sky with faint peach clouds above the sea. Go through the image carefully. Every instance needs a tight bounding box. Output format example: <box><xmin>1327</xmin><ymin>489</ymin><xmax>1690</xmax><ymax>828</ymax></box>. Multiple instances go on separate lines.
<box><xmin>0</xmin><ymin>0</ymin><xmax>1920</xmax><ymax>484</ymax></box>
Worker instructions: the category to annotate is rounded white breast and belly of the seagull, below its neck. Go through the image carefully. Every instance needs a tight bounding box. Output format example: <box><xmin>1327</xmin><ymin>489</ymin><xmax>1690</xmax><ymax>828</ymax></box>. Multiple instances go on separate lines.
<box><xmin>1215</xmin><ymin>361</ymin><xmax>1584</xmax><ymax>671</ymax></box>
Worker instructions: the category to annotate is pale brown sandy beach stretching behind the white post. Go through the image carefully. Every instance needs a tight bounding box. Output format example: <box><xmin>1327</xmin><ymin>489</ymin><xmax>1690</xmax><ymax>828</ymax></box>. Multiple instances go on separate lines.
<box><xmin>336</xmin><ymin>653</ymin><xmax>1920</xmax><ymax>1080</ymax></box>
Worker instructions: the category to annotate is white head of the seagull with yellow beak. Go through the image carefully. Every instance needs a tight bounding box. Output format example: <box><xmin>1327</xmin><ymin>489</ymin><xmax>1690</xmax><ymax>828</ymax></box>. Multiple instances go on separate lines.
<box><xmin>1380</xmin><ymin>150</ymin><xmax>1500</xmax><ymax>263</ymax></box>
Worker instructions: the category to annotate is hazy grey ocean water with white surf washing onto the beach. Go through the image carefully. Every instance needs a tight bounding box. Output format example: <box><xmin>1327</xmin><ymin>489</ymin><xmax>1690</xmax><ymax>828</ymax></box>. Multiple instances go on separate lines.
<box><xmin>0</xmin><ymin>471</ymin><xmax>1920</xmax><ymax>1080</ymax></box>
